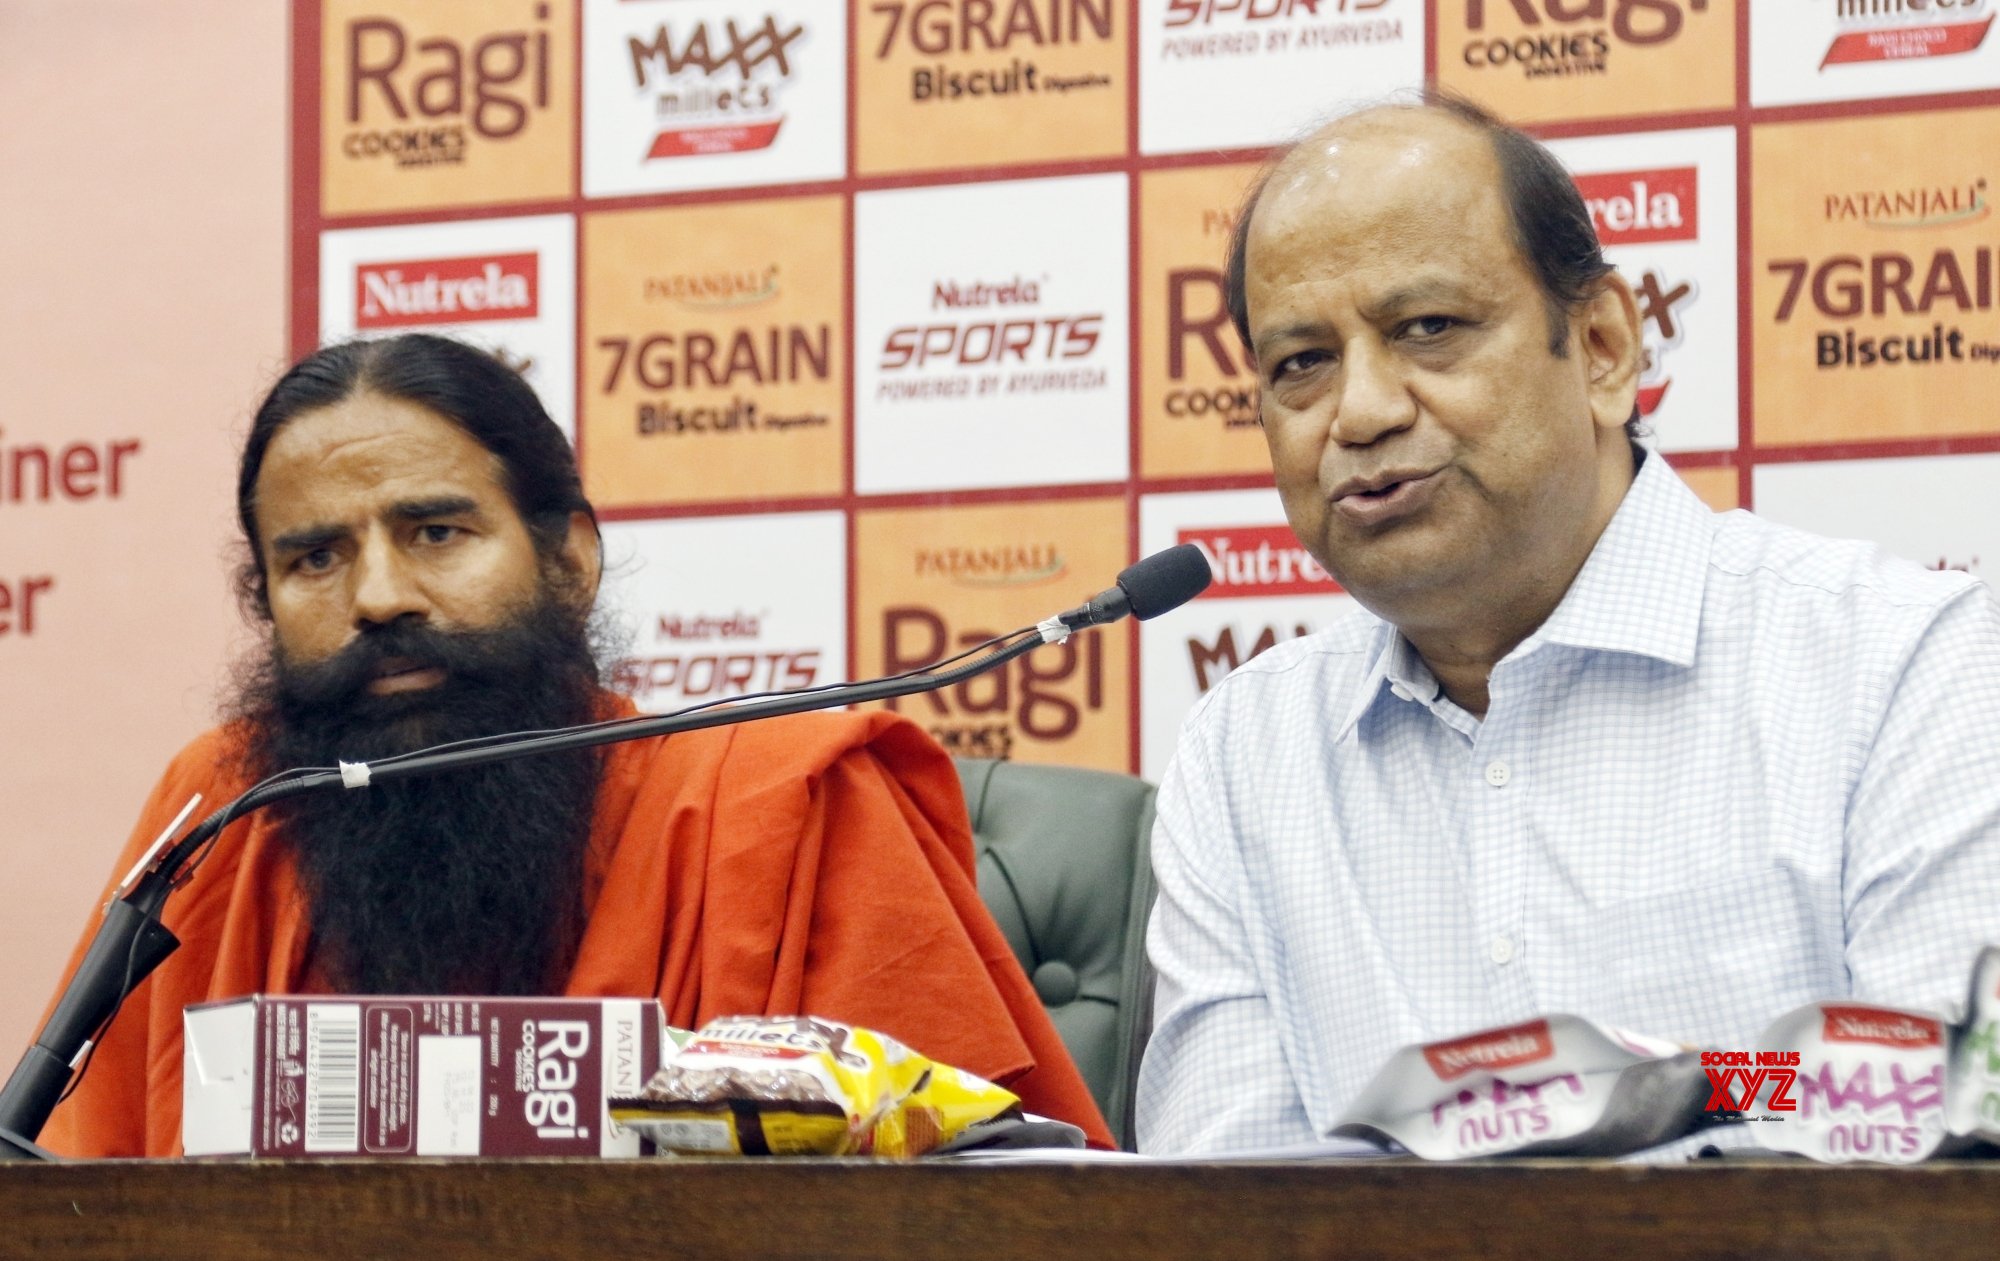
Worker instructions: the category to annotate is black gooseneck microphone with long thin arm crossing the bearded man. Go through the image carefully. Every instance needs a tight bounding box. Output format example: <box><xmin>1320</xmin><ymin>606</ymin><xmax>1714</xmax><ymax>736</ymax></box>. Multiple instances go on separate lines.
<box><xmin>0</xmin><ymin>542</ymin><xmax>1210</xmax><ymax>1161</ymax></box>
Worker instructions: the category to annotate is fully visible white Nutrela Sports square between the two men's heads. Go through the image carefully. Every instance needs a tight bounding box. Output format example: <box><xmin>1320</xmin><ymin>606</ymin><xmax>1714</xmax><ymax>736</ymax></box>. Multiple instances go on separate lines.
<box><xmin>854</xmin><ymin>174</ymin><xmax>1130</xmax><ymax>492</ymax></box>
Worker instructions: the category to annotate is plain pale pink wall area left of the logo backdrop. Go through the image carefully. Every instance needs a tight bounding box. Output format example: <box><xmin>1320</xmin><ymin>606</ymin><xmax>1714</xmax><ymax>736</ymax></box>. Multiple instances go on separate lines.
<box><xmin>0</xmin><ymin>0</ymin><xmax>288</xmax><ymax>1071</ymax></box>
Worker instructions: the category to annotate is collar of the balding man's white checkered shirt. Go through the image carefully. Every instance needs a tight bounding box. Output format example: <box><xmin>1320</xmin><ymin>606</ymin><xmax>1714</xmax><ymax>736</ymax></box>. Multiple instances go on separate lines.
<box><xmin>1334</xmin><ymin>452</ymin><xmax>1714</xmax><ymax>743</ymax></box>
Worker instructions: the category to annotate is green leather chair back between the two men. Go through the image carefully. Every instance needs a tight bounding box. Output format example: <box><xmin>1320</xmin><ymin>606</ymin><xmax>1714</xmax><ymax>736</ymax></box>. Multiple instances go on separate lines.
<box><xmin>954</xmin><ymin>759</ymin><xmax>1154</xmax><ymax>1149</ymax></box>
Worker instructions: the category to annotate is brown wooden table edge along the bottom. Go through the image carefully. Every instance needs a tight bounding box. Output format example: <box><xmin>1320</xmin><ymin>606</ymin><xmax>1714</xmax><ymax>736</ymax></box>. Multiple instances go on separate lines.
<box><xmin>0</xmin><ymin>1161</ymin><xmax>2000</xmax><ymax>1261</ymax></box>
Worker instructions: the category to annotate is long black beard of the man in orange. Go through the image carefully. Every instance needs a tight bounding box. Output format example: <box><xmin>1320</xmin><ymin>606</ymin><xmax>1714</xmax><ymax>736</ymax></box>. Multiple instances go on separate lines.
<box><xmin>236</xmin><ymin>598</ymin><xmax>600</xmax><ymax>995</ymax></box>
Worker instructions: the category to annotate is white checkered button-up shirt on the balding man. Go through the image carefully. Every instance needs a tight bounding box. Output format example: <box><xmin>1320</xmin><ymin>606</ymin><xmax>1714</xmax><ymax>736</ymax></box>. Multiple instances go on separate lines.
<box><xmin>1138</xmin><ymin>458</ymin><xmax>2000</xmax><ymax>1153</ymax></box>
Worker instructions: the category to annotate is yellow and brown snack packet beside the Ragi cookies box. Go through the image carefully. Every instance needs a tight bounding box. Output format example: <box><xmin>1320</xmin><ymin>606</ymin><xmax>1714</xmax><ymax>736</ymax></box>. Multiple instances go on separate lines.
<box><xmin>610</xmin><ymin>1017</ymin><xmax>1020</xmax><ymax>1157</ymax></box>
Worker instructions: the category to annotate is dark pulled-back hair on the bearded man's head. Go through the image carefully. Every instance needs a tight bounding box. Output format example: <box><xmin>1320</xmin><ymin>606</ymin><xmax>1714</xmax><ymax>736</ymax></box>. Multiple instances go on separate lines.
<box><xmin>236</xmin><ymin>332</ymin><xmax>596</xmax><ymax>616</ymax></box>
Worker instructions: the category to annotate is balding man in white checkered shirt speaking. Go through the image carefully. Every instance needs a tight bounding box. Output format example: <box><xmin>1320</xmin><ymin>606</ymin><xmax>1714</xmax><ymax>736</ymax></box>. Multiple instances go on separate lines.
<box><xmin>1138</xmin><ymin>98</ymin><xmax>2000</xmax><ymax>1153</ymax></box>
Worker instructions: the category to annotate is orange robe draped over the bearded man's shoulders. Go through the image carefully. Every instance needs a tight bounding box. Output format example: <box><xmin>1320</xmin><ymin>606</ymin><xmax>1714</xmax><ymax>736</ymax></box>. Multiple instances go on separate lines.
<box><xmin>40</xmin><ymin>705</ymin><xmax>1112</xmax><ymax>1157</ymax></box>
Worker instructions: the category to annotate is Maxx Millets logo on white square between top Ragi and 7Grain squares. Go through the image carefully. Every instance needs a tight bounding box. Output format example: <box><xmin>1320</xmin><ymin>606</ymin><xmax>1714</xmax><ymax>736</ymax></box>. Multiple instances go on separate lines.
<box><xmin>626</xmin><ymin>14</ymin><xmax>806</xmax><ymax>160</ymax></box>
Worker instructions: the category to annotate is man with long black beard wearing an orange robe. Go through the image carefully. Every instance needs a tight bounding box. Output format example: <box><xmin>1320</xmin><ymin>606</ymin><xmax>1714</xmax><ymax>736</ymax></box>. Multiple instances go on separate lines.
<box><xmin>42</xmin><ymin>334</ymin><xmax>1108</xmax><ymax>1155</ymax></box>
